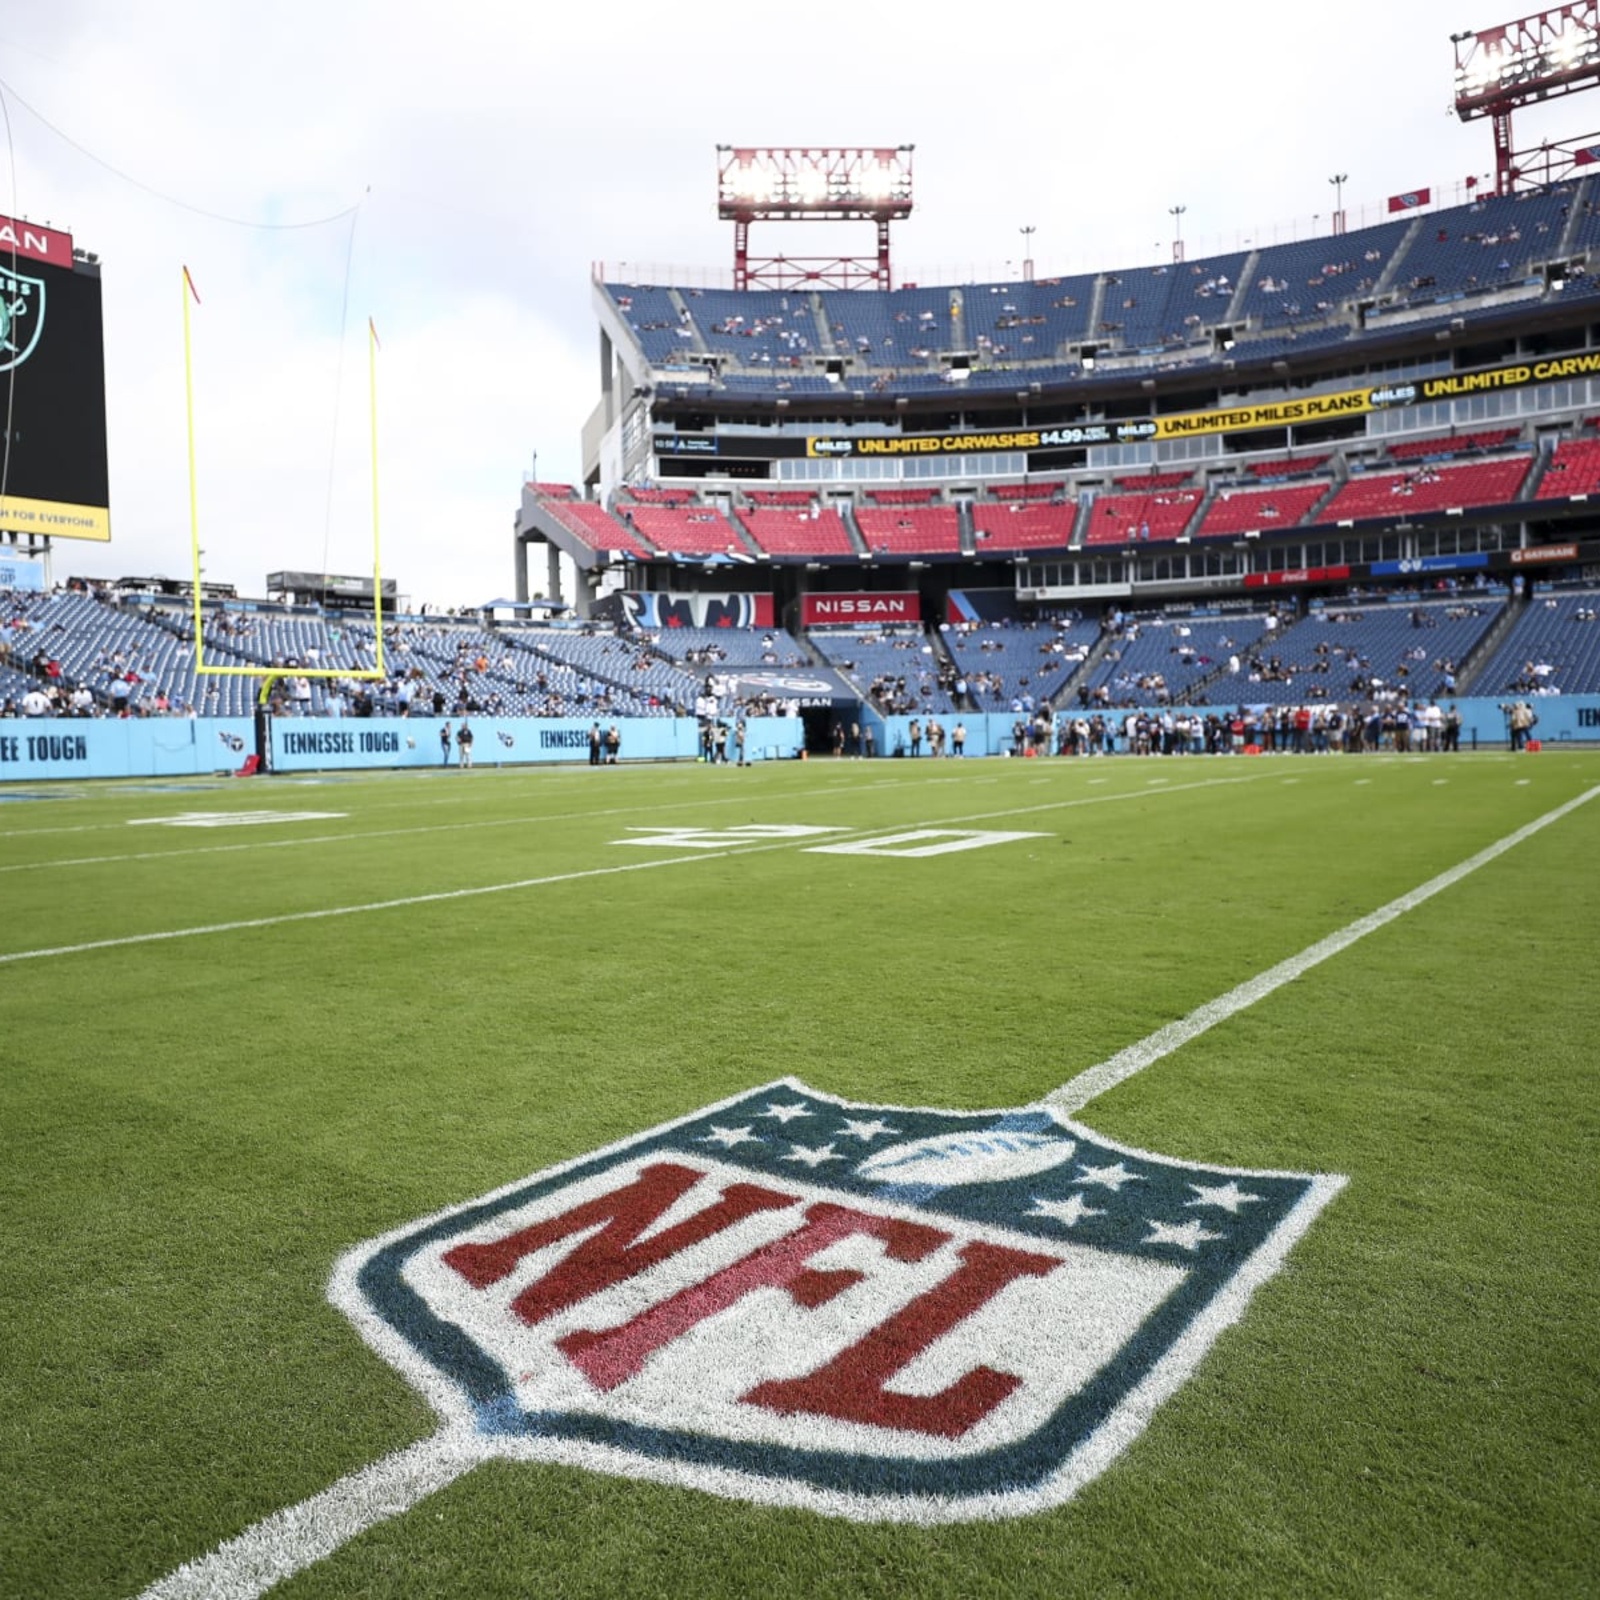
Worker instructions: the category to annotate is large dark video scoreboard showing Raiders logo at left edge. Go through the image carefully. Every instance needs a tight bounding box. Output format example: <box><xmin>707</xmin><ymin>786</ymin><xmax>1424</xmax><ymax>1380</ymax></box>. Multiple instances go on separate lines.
<box><xmin>0</xmin><ymin>216</ymin><xmax>110</xmax><ymax>539</ymax></box>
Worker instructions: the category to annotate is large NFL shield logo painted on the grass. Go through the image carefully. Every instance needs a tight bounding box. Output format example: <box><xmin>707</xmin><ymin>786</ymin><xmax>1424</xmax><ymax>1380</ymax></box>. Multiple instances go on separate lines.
<box><xmin>330</xmin><ymin>1078</ymin><xmax>1344</xmax><ymax>1522</ymax></box>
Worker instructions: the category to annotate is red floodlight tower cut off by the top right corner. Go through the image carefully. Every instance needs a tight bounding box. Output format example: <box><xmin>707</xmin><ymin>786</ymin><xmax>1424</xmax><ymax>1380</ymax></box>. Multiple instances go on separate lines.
<box><xmin>1450</xmin><ymin>0</ymin><xmax>1600</xmax><ymax>195</ymax></box>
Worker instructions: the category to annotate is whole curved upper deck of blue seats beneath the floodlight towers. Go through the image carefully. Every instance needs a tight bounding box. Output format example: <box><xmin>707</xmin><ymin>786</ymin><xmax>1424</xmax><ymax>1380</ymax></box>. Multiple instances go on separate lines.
<box><xmin>606</xmin><ymin>182</ymin><xmax>1600</xmax><ymax>395</ymax></box>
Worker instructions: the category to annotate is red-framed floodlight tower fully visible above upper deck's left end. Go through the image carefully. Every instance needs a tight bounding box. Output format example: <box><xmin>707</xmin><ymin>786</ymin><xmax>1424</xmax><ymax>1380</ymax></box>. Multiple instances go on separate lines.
<box><xmin>717</xmin><ymin>144</ymin><xmax>915</xmax><ymax>290</ymax></box>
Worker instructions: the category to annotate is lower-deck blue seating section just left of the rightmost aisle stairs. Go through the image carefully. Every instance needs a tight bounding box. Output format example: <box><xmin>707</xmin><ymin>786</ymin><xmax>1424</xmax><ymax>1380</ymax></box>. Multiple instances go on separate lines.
<box><xmin>1235</xmin><ymin>594</ymin><xmax>1506</xmax><ymax>706</ymax></box>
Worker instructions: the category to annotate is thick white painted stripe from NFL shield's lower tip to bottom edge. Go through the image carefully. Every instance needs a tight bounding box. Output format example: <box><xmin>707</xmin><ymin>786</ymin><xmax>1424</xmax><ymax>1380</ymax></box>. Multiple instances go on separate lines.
<box><xmin>139</xmin><ymin>1430</ymin><xmax>483</xmax><ymax>1600</ymax></box>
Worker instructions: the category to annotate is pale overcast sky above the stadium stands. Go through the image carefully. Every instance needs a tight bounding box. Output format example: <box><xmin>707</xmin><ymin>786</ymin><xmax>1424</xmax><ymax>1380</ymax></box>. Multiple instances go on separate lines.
<box><xmin>0</xmin><ymin>0</ymin><xmax>1580</xmax><ymax>605</ymax></box>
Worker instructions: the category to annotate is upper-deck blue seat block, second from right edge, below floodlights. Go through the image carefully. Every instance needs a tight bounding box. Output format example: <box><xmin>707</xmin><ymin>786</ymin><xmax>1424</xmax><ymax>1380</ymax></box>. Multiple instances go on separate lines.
<box><xmin>1390</xmin><ymin>186</ymin><xmax>1573</xmax><ymax>301</ymax></box>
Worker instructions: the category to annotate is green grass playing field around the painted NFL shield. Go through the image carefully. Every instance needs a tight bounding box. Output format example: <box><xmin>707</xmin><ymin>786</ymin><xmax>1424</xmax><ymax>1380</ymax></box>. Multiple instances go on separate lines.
<box><xmin>0</xmin><ymin>750</ymin><xmax>1600</xmax><ymax>1600</ymax></box>
